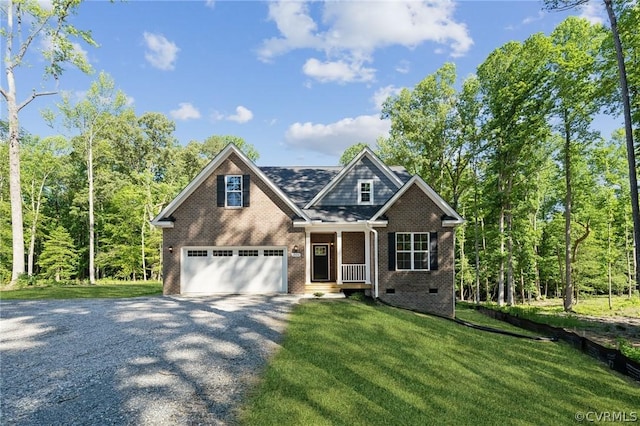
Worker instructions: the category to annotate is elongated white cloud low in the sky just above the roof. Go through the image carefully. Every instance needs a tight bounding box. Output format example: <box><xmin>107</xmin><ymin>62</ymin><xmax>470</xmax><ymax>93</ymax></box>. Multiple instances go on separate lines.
<box><xmin>285</xmin><ymin>115</ymin><xmax>391</xmax><ymax>155</ymax></box>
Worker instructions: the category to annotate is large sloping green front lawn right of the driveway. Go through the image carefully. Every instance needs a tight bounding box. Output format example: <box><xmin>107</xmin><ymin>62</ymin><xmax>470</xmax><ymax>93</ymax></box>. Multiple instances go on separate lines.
<box><xmin>240</xmin><ymin>301</ymin><xmax>640</xmax><ymax>425</ymax></box>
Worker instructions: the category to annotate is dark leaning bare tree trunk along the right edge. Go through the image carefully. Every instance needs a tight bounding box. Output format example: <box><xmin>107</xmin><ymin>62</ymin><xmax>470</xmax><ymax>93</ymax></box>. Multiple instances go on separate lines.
<box><xmin>604</xmin><ymin>0</ymin><xmax>640</xmax><ymax>294</ymax></box>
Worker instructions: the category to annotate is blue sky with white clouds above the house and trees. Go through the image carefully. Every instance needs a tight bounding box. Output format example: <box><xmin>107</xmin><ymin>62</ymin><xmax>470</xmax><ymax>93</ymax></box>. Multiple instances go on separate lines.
<box><xmin>5</xmin><ymin>0</ymin><xmax>622</xmax><ymax>165</ymax></box>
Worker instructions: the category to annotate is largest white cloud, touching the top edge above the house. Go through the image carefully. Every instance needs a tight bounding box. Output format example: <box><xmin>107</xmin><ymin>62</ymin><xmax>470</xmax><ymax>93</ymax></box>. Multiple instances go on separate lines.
<box><xmin>258</xmin><ymin>0</ymin><xmax>473</xmax><ymax>82</ymax></box>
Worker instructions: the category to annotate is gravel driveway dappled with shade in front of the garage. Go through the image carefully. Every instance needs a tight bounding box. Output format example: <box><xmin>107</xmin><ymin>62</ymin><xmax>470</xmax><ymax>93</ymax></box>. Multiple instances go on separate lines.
<box><xmin>0</xmin><ymin>295</ymin><xmax>299</xmax><ymax>425</ymax></box>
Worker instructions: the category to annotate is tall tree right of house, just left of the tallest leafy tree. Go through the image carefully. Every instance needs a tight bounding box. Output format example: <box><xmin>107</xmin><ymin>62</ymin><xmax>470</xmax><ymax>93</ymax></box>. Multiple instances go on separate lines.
<box><xmin>478</xmin><ymin>34</ymin><xmax>550</xmax><ymax>304</ymax></box>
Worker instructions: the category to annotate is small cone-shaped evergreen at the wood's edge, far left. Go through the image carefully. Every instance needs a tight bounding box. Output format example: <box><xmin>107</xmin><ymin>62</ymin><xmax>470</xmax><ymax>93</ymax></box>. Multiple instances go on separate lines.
<box><xmin>38</xmin><ymin>225</ymin><xmax>78</xmax><ymax>281</ymax></box>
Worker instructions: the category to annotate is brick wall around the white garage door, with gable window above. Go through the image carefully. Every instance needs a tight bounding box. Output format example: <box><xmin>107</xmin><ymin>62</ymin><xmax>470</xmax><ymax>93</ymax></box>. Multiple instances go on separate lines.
<box><xmin>163</xmin><ymin>154</ymin><xmax>305</xmax><ymax>294</ymax></box>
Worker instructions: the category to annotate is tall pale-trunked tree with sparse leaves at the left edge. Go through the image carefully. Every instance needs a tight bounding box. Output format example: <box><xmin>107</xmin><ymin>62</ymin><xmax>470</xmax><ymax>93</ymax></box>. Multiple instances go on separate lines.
<box><xmin>0</xmin><ymin>0</ymin><xmax>96</xmax><ymax>282</ymax></box>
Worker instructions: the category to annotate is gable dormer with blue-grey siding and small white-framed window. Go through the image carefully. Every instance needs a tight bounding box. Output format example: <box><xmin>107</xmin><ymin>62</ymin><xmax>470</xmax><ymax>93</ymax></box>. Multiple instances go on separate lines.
<box><xmin>306</xmin><ymin>148</ymin><xmax>403</xmax><ymax>208</ymax></box>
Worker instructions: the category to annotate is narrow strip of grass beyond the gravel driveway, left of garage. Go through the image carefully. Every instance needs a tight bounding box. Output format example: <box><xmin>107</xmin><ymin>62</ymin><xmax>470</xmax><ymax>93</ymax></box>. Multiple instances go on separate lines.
<box><xmin>0</xmin><ymin>281</ymin><xmax>162</xmax><ymax>300</ymax></box>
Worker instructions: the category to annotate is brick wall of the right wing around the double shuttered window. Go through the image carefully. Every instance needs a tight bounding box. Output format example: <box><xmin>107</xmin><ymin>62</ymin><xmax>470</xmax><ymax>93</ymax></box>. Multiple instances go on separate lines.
<box><xmin>378</xmin><ymin>185</ymin><xmax>455</xmax><ymax>317</ymax></box>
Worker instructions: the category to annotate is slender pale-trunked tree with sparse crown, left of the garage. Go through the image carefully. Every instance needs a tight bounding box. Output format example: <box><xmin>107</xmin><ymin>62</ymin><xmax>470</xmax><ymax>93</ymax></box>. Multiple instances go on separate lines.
<box><xmin>53</xmin><ymin>72</ymin><xmax>126</xmax><ymax>284</ymax></box>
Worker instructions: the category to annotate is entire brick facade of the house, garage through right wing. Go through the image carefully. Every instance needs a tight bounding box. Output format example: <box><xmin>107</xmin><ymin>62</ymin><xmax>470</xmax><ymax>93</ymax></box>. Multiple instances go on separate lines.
<box><xmin>163</xmin><ymin>148</ymin><xmax>462</xmax><ymax>316</ymax></box>
